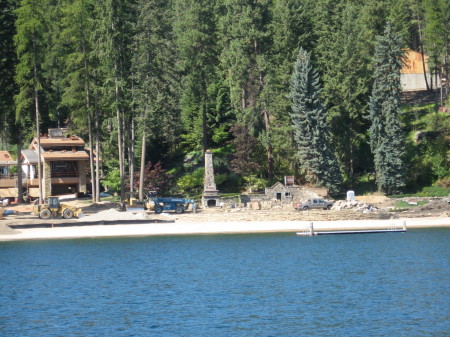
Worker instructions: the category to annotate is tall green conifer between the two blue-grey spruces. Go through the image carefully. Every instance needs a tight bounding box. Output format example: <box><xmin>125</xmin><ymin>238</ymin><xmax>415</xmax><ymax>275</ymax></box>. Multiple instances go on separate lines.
<box><xmin>320</xmin><ymin>3</ymin><xmax>373</xmax><ymax>185</ymax></box>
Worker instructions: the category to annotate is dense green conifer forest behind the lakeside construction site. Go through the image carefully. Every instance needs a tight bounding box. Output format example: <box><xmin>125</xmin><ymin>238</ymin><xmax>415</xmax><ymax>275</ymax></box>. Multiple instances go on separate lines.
<box><xmin>0</xmin><ymin>0</ymin><xmax>450</xmax><ymax>200</ymax></box>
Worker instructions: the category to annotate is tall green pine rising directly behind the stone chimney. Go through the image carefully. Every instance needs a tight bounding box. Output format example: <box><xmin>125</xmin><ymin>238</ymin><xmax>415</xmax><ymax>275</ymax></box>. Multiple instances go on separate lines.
<box><xmin>173</xmin><ymin>0</ymin><xmax>217</xmax><ymax>151</ymax></box>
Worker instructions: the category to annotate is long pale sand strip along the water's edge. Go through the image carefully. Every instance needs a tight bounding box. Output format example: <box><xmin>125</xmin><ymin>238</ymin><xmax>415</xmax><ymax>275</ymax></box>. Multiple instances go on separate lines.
<box><xmin>0</xmin><ymin>217</ymin><xmax>450</xmax><ymax>242</ymax></box>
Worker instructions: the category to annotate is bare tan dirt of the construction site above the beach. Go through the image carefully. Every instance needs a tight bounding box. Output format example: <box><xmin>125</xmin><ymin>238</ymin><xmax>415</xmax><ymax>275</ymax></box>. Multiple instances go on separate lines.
<box><xmin>1</xmin><ymin>197</ymin><xmax>450</xmax><ymax>225</ymax></box>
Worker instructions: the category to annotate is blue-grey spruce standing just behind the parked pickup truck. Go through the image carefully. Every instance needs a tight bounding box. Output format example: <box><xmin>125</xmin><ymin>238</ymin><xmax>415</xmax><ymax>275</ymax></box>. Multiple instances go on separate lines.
<box><xmin>290</xmin><ymin>49</ymin><xmax>342</xmax><ymax>195</ymax></box>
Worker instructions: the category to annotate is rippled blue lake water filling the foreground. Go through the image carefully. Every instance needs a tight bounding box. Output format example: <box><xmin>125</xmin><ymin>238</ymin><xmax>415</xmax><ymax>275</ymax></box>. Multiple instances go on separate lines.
<box><xmin>0</xmin><ymin>229</ymin><xmax>450</xmax><ymax>337</ymax></box>
